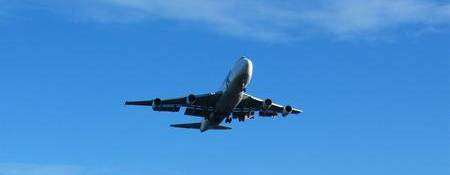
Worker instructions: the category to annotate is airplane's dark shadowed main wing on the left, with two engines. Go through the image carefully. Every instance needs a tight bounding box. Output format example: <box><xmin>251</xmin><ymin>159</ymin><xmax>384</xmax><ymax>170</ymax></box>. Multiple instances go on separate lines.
<box><xmin>125</xmin><ymin>92</ymin><xmax>222</xmax><ymax>115</ymax></box>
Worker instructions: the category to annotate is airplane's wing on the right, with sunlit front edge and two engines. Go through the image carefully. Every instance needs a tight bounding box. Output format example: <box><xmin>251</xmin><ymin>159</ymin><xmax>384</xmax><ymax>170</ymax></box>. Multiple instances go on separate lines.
<box><xmin>233</xmin><ymin>94</ymin><xmax>303</xmax><ymax>117</ymax></box>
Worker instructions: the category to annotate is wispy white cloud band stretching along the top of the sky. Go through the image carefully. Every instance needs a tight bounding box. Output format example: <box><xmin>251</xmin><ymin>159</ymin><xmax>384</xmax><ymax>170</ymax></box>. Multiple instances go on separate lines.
<box><xmin>2</xmin><ymin>0</ymin><xmax>450</xmax><ymax>41</ymax></box>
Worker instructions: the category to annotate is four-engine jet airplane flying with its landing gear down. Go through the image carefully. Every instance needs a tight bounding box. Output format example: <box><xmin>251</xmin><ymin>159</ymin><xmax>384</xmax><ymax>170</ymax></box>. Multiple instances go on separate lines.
<box><xmin>125</xmin><ymin>56</ymin><xmax>303</xmax><ymax>132</ymax></box>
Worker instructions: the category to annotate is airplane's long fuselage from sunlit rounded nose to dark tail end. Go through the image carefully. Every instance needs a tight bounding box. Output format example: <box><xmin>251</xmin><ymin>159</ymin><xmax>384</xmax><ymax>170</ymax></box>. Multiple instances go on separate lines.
<box><xmin>200</xmin><ymin>57</ymin><xmax>253</xmax><ymax>132</ymax></box>
